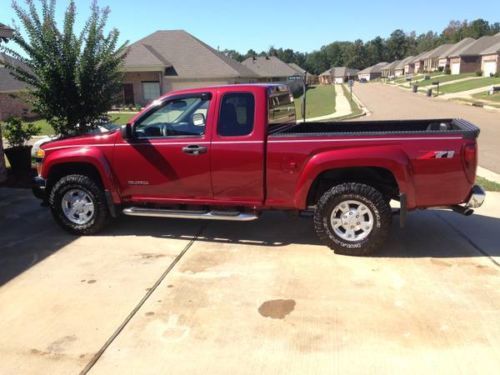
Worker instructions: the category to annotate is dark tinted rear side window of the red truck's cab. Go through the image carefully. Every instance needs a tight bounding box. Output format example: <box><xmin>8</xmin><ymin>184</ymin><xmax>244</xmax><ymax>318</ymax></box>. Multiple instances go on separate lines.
<box><xmin>217</xmin><ymin>93</ymin><xmax>255</xmax><ymax>137</ymax></box>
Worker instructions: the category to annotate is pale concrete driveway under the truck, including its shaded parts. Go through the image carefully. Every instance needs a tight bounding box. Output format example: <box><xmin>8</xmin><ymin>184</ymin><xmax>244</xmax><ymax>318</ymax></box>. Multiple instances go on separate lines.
<box><xmin>0</xmin><ymin>189</ymin><xmax>500</xmax><ymax>374</ymax></box>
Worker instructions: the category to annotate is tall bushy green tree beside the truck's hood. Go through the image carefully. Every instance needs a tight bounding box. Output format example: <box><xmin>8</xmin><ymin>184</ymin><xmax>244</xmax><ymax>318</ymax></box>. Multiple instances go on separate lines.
<box><xmin>4</xmin><ymin>0</ymin><xmax>125</xmax><ymax>135</ymax></box>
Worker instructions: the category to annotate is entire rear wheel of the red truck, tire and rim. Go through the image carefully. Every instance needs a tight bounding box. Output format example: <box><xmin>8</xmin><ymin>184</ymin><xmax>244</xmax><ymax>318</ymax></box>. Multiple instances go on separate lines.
<box><xmin>314</xmin><ymin>183</ymin><xmax>392</xmax><ymax>255</ymax></box>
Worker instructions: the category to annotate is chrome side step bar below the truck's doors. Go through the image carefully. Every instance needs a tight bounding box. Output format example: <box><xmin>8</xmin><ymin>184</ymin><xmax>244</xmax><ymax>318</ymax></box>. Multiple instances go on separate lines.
<box><xmin>123</xmin><ymin>207</ymin><xmax>258</xmax><ymax>221</ymax></box>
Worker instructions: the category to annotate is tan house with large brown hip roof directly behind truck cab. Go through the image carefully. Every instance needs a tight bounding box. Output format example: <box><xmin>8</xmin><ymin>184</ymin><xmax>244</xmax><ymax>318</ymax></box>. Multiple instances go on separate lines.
<box><xmin>123</xmin><ymin>30</ymin><xmax>258</xmax><ymax>105</ymax></box>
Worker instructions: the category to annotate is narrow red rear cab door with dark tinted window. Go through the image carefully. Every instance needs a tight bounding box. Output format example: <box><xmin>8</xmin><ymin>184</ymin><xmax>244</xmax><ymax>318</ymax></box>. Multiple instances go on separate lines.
<box><xmin>211</xmin><ymin>87</ymin><xmax>266</xmax><ymax>206</ymax></box>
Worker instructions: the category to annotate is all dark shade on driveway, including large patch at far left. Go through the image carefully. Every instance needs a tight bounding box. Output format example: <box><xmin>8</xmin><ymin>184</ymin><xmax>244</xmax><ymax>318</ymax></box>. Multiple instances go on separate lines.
<box><xmin>0</xmin><ymin>188</ymin><xmax>500</xmax><ymax>286</ymax></box>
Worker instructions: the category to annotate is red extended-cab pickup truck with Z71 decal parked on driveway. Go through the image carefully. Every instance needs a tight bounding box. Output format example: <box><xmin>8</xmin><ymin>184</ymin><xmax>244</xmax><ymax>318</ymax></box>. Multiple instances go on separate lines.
<box><xmin>34</xmin><ymin>84</ymin><xmax>485</xmax><ymax>255</ymax></box>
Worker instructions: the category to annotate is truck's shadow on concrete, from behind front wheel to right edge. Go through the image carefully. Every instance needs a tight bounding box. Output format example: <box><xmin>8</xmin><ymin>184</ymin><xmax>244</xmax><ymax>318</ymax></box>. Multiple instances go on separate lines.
<box><xmin>103</xmin><ymin>210</ymin><xmax>500</xmax><ymax>258</ymax></box>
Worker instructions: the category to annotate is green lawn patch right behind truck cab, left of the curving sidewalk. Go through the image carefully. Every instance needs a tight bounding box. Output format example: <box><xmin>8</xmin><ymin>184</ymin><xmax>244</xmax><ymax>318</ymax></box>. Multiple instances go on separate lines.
<box><xmin>294</xmin><ymin>85</ymin><xmax>335</xmax><ymax>119</ymax></box>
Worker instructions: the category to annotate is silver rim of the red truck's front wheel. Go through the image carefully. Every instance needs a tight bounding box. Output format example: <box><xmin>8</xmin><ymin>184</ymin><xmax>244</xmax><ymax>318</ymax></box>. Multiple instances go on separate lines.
<box><xmin>61</xmin><ymin>189</ymin><xmax>95</xmax><ymax>225</ymax></box>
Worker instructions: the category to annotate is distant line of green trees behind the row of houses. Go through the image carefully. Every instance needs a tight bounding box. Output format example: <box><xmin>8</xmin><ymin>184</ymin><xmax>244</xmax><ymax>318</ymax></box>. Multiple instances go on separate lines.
<box><xmin>224</xmin><ymin>19</ymin><xmax>500</xmax><ymax>74</ymax></box>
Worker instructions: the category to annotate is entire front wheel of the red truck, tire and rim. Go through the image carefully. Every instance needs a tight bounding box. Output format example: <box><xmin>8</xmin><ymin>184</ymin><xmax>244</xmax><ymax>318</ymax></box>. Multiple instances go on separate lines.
<box><xmin>49</xmin><ymin>175</ymin><xmax>110</xmax><ymax>235</ymax></box>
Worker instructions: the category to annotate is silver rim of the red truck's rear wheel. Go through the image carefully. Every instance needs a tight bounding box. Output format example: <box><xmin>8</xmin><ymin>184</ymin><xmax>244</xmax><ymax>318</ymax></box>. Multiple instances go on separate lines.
<box><xmin>330</xmin><ymin>200</ymin><xmax>374</xmax><ymax>242</ymax></box>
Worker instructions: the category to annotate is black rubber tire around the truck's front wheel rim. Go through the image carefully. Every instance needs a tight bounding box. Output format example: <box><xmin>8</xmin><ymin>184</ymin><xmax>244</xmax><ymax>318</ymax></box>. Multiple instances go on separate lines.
<box><xmin>49</xmin><ymin>174</ymin><xmax>111</xmax><ymax>235</ymax></box>
